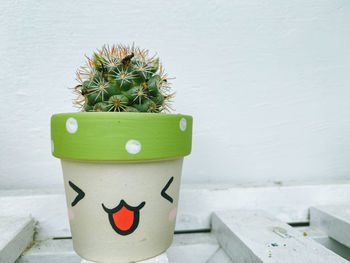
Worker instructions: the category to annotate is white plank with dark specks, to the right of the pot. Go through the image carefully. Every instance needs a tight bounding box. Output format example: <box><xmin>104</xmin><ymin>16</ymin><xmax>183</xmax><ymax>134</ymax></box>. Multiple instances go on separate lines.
<box><xmin>212</xmin><ymin>210</ymin><xmax>348</xmax><ymax>263</ymax></box>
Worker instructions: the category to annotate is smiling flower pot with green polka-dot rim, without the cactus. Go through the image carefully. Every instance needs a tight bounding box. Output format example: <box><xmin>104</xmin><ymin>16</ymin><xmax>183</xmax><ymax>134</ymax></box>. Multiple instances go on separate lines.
<box><xmin>51</xmin><ymin>112</ymin><xmax>192</xmax><ymax>263</ymax></box>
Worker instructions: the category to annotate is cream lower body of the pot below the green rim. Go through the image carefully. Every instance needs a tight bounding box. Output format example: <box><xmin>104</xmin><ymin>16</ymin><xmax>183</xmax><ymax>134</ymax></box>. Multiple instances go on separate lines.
<box><xmin>61</xmin><ymin>158</ymin><xmax>183</xmax><ymax>263</ymax></box>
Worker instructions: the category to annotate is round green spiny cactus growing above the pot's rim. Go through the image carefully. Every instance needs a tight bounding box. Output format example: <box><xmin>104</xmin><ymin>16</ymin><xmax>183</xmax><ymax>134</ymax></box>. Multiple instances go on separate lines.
<box><xmin>74</xmin><ymin>45</ymin><xmax>174</xmax><ymax>113</ymax></box>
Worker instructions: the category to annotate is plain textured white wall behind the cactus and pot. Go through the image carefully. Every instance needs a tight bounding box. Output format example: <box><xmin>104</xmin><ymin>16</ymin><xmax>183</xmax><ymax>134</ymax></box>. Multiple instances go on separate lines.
<box><xmin>0</xmin><ymin>0</ymin><xmax>350</xmax><ymax>189</ymax></box>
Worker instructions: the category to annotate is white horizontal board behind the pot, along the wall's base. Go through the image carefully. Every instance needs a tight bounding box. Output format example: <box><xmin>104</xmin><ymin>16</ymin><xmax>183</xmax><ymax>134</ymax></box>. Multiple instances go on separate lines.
<box><xmin>0</xmin><ymin>182</ymin><xmax>350</xmax><ymax>240</ymax></box>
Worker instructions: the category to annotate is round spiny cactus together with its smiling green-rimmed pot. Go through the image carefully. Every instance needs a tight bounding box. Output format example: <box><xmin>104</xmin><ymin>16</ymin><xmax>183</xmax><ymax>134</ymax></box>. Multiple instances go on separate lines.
<box><xmin>51</xmin><ymin>45</ymin><xmax>192</xmax><ymax>263</ymax></box>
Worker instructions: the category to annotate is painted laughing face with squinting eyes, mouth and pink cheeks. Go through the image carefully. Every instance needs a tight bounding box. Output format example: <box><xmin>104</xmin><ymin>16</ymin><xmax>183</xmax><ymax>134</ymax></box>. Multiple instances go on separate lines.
<box><xmin>68</xmin><ymin>176</ymin><xmax>177</xmax><ymax>236</ymax></box>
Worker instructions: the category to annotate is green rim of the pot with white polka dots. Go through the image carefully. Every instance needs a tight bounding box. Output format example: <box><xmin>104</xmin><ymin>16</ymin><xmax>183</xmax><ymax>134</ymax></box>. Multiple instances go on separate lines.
<box><xmin>51</xmin><ymin>112</ymin><xmax>192</xmax><ymax>161</ymax></box>
